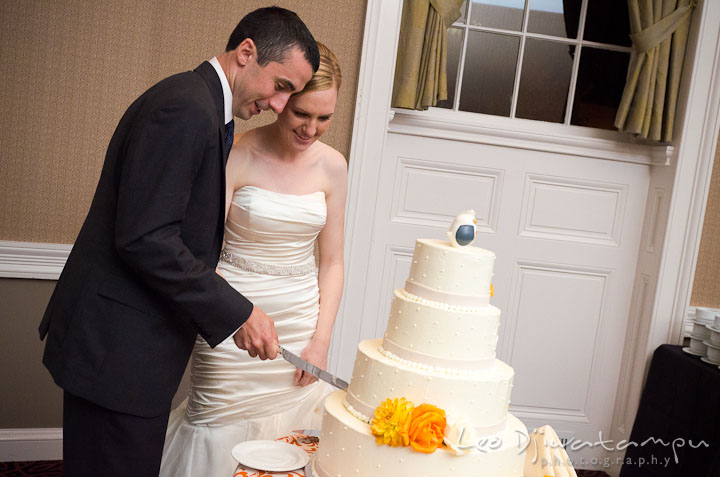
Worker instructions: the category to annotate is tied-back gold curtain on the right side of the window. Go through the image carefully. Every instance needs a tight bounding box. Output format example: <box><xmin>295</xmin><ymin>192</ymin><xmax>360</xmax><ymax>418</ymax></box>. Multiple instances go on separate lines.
<box><xmin>615</xmin><ymin>0</ymin><xmax>695</xmax><ymax>141</ymax></box>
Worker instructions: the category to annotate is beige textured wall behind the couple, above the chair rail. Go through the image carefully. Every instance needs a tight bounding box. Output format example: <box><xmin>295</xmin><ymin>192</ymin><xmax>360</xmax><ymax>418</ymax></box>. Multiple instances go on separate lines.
<box><xmin>0</xmin><ymin>0</ymin><xmax>366</xmax><ymax>243</ymax></box>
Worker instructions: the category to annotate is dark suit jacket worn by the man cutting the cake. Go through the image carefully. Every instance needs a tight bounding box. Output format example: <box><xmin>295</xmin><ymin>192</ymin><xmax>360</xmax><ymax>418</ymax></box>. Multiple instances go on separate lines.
<box><xmin>40</xmin><ymin>62</ymin><xmax>252</xmax><ymax>417</ymax></box>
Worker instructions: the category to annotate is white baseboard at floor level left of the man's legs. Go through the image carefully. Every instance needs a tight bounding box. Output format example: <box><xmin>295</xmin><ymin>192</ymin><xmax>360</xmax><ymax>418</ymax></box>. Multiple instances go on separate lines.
<box><xmin>0</xmin><ymin>428</ymin><xmax>62</xmax><ymax>462</ymax></box>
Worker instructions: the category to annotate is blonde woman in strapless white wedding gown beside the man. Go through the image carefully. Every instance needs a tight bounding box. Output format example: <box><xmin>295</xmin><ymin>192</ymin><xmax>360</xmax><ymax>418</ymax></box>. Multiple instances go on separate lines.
<box><xmin>160</xmin><ymin>43</ymin><xmax>347</xmax><ymax>477</ymax></box>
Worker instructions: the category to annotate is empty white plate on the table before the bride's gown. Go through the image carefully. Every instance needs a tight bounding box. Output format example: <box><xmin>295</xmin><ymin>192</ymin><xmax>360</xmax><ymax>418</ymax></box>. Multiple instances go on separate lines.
<box><xmin>231</xmin><ymin>441</ymin><xmax>310</xmax><ymax>472</ymax></box>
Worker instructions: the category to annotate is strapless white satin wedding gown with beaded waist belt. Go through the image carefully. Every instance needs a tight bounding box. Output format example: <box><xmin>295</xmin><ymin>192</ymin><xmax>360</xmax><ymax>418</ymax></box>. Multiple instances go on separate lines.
<box><xmin>160</xmin><ymin>186</ymin><xmax>333</xmax><ymax>477</ymax></box>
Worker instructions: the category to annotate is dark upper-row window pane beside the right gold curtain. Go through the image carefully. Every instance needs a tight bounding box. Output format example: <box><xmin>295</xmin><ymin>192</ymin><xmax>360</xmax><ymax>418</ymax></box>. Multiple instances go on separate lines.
<box><xmin>583</xmin><ymin>0</ymin><xmax>631</xmax><ymax>46</ymax></box>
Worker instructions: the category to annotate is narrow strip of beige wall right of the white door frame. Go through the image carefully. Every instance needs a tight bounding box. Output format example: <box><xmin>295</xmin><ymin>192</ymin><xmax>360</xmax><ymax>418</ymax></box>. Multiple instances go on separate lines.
<box><xmin>690</xmin><ymin>136</ymin><xmax>720</xmax><ymax>308</ymax></box>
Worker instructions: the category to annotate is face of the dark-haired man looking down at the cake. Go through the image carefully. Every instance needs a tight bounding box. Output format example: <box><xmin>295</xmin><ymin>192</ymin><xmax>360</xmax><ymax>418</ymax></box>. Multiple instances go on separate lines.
<box><xmin>233</xmin><ymin>47</ymin><xmax>313</xmax><ymax>119</ymax></box>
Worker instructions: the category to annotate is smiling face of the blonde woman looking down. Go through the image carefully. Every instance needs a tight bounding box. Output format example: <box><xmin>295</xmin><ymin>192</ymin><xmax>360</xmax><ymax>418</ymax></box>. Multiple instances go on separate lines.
<box><xmin>278</xmin><ymin>87</ymin><xmax>337</xmax><ymax>151</ymax></box>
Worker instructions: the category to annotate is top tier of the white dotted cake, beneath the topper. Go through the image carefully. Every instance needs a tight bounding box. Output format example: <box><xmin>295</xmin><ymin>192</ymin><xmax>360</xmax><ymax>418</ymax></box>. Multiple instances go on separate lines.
<box><xmin>405</xmin><ymin>239</ymin><xmax>495</xmax><ymax>306</ymax></box>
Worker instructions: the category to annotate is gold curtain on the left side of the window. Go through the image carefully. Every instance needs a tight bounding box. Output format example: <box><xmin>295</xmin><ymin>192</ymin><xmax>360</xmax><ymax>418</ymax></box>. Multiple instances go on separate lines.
<box><xmin>391</xmin><ymin>0</ymin><xmax>463</xmax><ymax>110</ymax></box>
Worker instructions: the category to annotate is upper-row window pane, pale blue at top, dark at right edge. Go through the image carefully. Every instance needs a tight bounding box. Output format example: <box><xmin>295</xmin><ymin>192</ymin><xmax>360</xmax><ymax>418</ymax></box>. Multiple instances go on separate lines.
<box><xmin>528</xmin><ymin>0</ymin><xmax>582</xmax><ymax>38</ymax></box>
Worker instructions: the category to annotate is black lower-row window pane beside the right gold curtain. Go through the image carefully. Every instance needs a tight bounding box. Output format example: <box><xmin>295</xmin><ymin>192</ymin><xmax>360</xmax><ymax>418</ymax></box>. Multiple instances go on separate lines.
<box><xmin>570</xmin><ymin>47</ymin><xmax>630</xmax><ymax>130</ymax></box>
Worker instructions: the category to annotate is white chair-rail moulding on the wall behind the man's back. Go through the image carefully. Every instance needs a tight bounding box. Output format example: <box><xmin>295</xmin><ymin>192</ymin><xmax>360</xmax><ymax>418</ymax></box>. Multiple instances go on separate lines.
<box><xmin>0</xmin><ymin>240</ymin><xmax>72</xmax><ymax>280</ymax></box>
